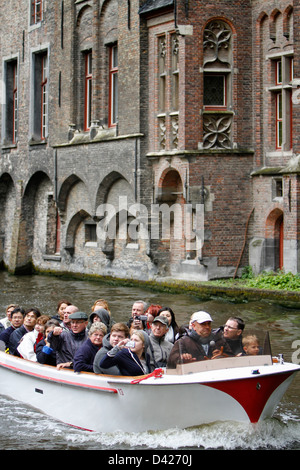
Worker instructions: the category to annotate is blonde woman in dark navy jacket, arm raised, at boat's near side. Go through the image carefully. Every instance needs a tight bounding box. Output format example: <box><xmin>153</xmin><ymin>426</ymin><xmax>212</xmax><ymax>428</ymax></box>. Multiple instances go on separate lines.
<box><xmin>100</xmin><ymin>330</ymin><xmax>152</xmax><ymax>376</ymax></box>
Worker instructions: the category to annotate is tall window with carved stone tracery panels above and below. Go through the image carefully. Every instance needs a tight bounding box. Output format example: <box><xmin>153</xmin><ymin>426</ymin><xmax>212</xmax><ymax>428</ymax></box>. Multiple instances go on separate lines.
<box><xmin>203</xmin><ymin>20</ymin><xmax>233</xmax><ymax>149</ymax></box>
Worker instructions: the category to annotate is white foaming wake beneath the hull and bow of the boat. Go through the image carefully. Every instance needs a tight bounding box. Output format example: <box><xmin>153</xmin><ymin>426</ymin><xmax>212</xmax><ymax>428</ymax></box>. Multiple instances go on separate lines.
<box><xmin>75</xmin><ymin>418</ymin><xmax>300</xmax><ymax>451</ymax></box>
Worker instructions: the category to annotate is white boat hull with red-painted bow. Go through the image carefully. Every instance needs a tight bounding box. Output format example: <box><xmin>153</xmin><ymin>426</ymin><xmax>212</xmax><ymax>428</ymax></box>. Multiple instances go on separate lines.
<box><xmin>0</xmin><ymin>352</ymin><xmax>300</xmax><ymax>432</ymax></box>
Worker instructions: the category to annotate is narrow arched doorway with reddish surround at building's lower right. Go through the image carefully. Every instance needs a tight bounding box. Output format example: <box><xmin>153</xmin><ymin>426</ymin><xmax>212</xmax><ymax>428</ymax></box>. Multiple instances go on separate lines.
<box><xmin>264</xmin><ymin>208</ymin><xmax>284</xmax><ymax>271</ymax></box>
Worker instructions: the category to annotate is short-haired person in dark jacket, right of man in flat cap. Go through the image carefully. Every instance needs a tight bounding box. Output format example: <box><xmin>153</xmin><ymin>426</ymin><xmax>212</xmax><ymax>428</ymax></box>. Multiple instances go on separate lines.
<box><xmin>73</xmin><ymin>322</ymin><xmax>107</xmax><ymax>372</ymax></box>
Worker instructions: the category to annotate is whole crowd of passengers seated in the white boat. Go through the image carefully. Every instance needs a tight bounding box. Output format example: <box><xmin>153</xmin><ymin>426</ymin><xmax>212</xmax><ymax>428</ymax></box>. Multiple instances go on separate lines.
<box><xmin>0</xmin><ymin>299</ymin><xmax>262</xmax><ymax>376</ymax></box>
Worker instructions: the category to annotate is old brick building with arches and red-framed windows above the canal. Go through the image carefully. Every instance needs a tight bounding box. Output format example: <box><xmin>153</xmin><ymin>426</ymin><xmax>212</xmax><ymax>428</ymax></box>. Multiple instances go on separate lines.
<box><xmin>0</xmin><ymin>0</ymin><xmax>300</xmax><ymax>280</ymax></box>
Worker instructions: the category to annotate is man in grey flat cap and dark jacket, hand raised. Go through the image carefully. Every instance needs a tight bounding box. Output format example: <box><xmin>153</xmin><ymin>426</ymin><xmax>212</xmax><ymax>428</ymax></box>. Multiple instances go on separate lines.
<box><xmin>48</xmin><ymin>312</ymin><xmax>88</xmax><ymax>369</ymax></box>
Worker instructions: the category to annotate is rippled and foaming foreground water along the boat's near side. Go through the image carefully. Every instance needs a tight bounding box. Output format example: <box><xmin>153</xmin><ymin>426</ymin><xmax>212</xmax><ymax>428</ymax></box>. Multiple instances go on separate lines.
<box><xmin>0</xmin><ymin>397</ymin><xmax>300</xmax><ymax>451</ymax></box>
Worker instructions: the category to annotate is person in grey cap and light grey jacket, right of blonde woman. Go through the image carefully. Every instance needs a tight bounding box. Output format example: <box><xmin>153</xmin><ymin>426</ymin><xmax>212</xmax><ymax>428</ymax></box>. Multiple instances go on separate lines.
<box><xmin>149</xmin><ymin>316</ymin><xmax>173</xmax><ymax>369</ymax></box>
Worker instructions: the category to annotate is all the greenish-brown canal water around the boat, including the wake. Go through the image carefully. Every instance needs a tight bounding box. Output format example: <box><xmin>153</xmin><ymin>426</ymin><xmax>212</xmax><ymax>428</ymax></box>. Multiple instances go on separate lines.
<box><xmin>0</xmin><ymin>272</ymin><xmax>300</xmax><ymax>452</ymax></box>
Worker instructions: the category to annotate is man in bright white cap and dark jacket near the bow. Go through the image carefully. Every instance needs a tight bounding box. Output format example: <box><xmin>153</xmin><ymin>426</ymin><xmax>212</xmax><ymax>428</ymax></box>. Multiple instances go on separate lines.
<box><xmin>168</xmin><ymin>311</ymin><xmax>232</xmax><ymax>368</ymax></box>
